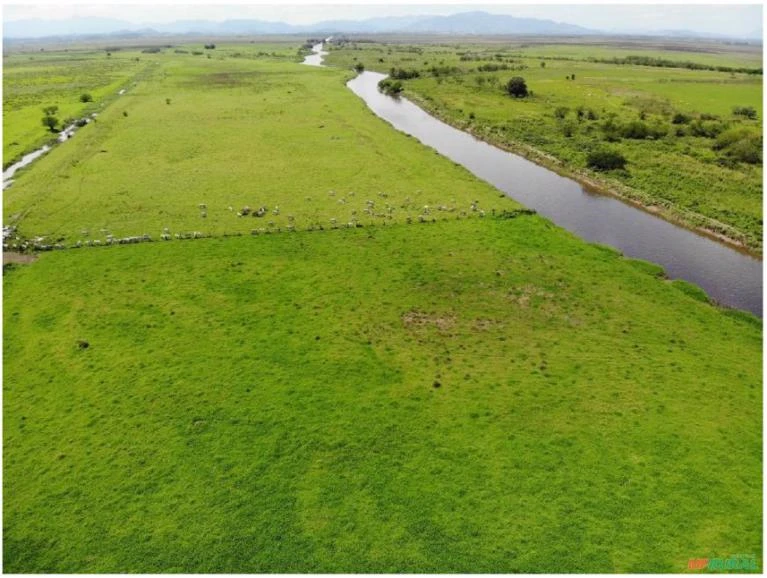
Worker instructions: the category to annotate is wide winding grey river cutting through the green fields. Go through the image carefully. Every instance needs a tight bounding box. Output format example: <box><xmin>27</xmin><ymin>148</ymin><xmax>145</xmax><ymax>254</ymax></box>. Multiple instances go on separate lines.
<box><xmin>313</xmin><ymin>44</ymin><xmax>762</xmax><ymax>317</ymax></box>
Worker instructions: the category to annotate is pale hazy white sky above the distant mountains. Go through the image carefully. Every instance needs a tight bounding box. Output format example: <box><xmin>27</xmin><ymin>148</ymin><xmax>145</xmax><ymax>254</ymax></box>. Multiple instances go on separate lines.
<box><xmin>3</xmin><ymin>0</ymin><xmax>762</xmax><ymax>35</ymax></box>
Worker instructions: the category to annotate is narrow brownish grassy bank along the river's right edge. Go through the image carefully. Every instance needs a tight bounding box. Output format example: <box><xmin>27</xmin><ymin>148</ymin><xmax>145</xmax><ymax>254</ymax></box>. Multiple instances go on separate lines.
<box><xmin>402</xmin><ymin>88</ymin><xmax>763</xmax><ymax>254</ymax></box>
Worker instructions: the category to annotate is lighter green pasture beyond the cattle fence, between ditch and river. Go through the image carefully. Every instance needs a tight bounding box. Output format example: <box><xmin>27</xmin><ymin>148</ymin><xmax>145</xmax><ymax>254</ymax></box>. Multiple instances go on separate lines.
<box><xmin>5</xmin><ymin>55</ymin><xmax>518</xmax><ymax>242</ymax></box>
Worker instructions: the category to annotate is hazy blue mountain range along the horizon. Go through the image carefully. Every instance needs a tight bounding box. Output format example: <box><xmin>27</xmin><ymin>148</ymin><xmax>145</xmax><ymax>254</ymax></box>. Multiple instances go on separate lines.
<box><xmin>3</xmin><ymin>11</ymin><xmax>761</xmax><ymax>39</ymax></box>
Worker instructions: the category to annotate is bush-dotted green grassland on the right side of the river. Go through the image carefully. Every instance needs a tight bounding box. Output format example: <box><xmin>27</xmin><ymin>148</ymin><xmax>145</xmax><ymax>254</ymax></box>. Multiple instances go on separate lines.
<box><xmin>328</xmin><ymin>38</ymin><xmax>763</xmax><ymax>253</ymax></box>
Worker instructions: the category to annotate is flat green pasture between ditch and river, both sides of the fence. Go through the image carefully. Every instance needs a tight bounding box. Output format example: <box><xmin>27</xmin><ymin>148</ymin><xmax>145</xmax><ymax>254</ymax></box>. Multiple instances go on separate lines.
<box><xmin>3</xmin><ymin>40</ymin><xmax>762</xmax><ymax>572</ymax></box>
